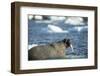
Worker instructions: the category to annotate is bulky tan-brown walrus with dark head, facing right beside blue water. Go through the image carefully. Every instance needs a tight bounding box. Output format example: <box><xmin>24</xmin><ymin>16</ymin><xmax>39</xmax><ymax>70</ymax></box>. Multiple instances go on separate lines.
<box><xmin>28</xmin><ymin>39</ymin><xmax>70</xmax><ymax>60</ymax></box>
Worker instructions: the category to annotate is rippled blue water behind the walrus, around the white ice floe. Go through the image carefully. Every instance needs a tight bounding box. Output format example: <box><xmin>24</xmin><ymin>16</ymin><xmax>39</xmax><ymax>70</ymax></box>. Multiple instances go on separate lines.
<box><xmin>28</xmin><ymin>20</ymin><xmax>88</xmax><ymax>59</ymax></box>
